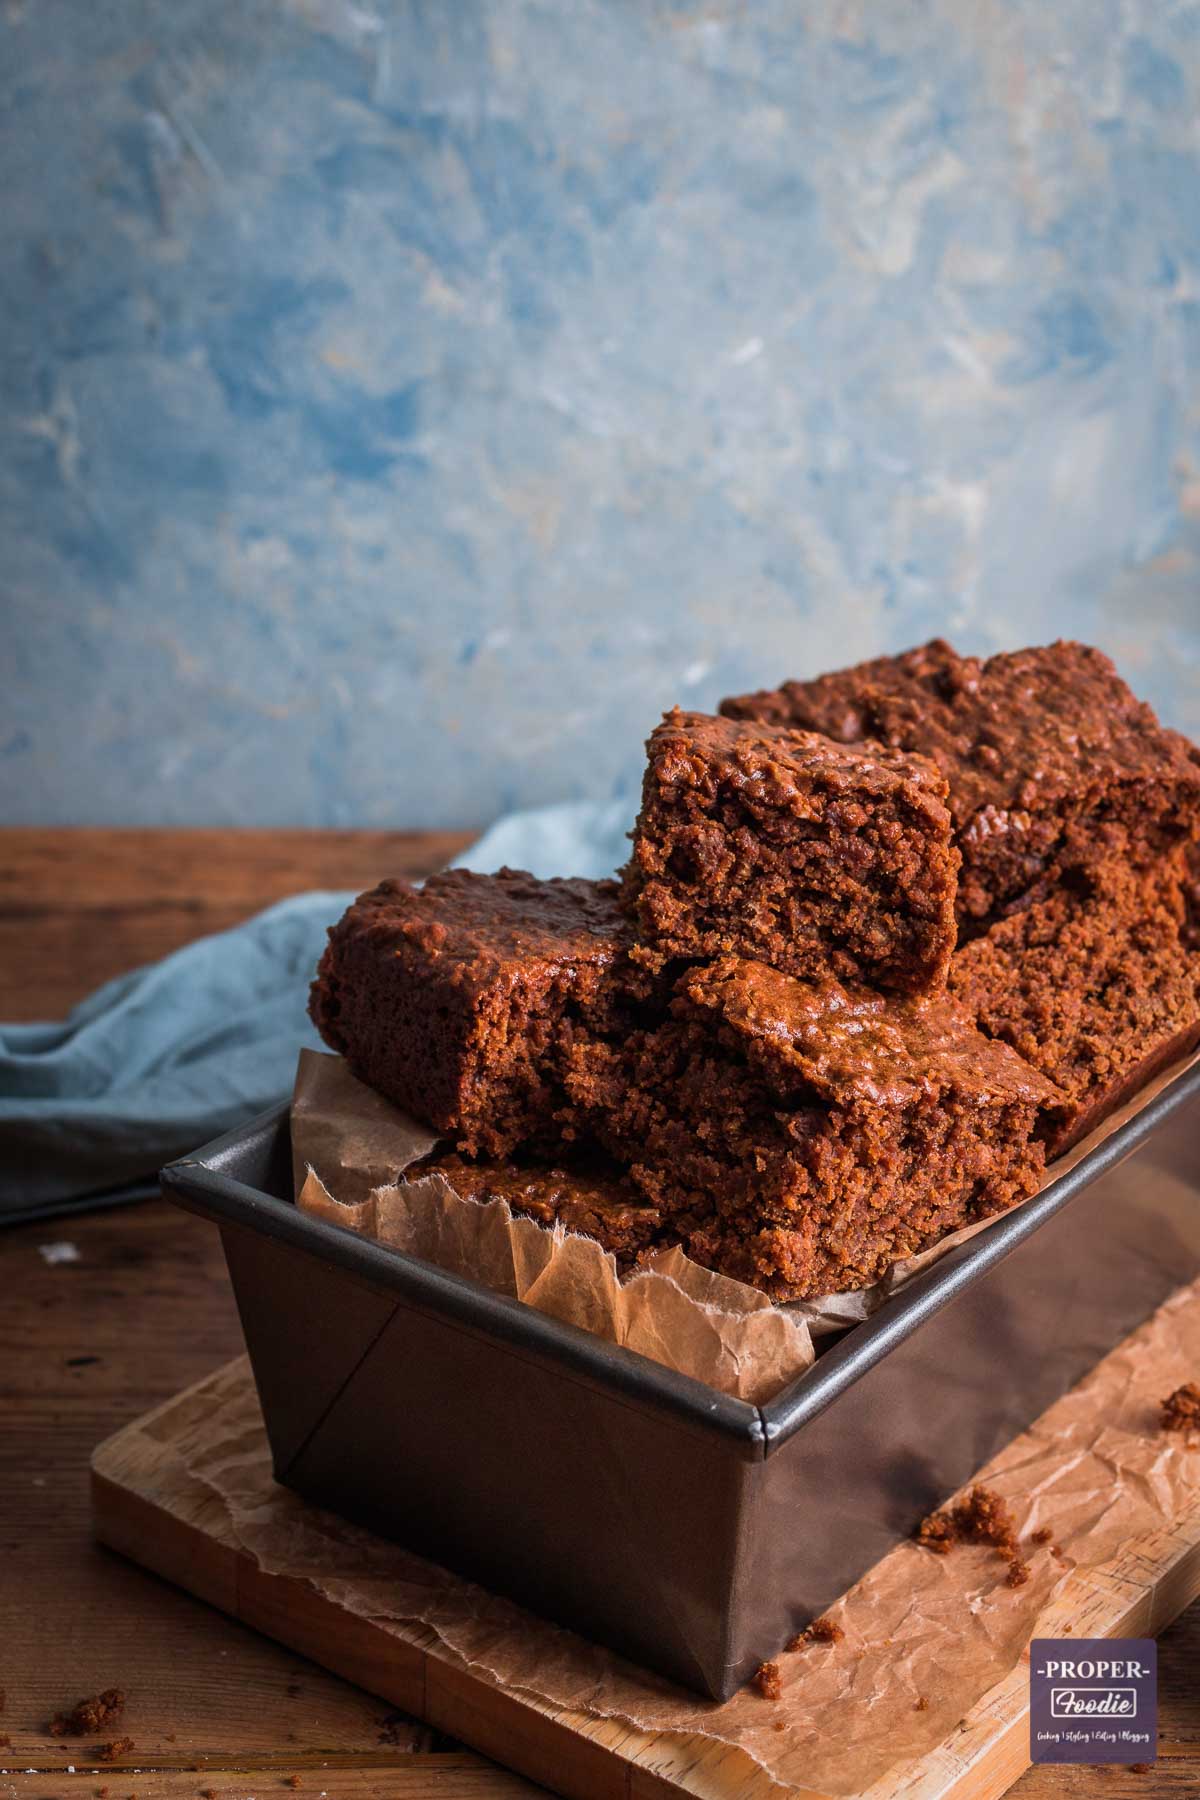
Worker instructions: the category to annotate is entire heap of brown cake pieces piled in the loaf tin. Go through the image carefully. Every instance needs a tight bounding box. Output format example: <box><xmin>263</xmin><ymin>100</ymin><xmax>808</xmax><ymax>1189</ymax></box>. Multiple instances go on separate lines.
<box><xmin>311</xmin><ymin>644</ymin><xmax>1200</xmax><ymax>1300</ymax></box>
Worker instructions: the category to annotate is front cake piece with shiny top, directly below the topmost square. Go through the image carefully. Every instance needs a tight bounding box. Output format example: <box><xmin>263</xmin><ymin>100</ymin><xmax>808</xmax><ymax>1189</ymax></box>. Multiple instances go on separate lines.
<box><xmin>567</xmin><ymin>958</ymin><xmax>1060</xmax><ymax>1300</ymax></box>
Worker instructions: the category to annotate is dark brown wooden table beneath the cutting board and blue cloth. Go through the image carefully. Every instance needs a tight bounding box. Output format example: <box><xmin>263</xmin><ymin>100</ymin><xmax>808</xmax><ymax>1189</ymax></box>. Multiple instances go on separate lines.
<box><xmin>0</xmin><ymin>830</ymin><xmax>1200</xmax><ymax>1800</ymax></box>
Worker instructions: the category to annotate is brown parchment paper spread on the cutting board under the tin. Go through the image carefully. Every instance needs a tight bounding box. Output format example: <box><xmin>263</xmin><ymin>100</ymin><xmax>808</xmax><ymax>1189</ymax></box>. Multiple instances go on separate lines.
<box><xmin>158</xmin><ymin>1282</ymin><xmax>1200</xmax><ymax>1800</ymax></box>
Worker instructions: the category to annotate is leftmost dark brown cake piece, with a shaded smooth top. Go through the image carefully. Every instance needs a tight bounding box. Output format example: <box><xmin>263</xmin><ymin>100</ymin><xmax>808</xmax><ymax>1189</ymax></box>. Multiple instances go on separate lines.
<box><xmin>309</xmin><ymin>869</ymin><xmax>647</xmax><ymax>1156</ymax></box>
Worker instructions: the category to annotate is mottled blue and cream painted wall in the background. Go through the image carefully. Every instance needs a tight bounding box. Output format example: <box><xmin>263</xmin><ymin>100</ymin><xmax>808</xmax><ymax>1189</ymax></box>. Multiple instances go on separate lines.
<box><xmin>0</xmin><ymin>0</ymin><xmax>1200</xmax><ymax>824</ymax></box>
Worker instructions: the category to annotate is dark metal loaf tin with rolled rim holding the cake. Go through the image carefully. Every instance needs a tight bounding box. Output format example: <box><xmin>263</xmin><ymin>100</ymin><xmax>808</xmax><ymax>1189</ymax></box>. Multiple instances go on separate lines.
<box><xmin>162</xmin><ymin>1067</ymin><xmax>1200</xmax><ymax>1699</ymax></box>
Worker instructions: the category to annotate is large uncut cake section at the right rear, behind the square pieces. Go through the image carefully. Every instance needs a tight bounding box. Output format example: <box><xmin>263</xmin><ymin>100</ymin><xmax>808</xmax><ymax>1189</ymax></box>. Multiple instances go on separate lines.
<box><xmin>721</xmin><ymin>639</ymin><xmax>1200</xmax><ymax>1154</ymax></box>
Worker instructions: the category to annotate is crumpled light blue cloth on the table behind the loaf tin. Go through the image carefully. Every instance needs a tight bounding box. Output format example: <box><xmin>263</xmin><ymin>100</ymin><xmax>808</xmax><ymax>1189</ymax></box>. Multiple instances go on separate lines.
<box><xmin>0</xmin><ymin>803</ymin><xmax>630</xmax><ymax>1222</ymax></box>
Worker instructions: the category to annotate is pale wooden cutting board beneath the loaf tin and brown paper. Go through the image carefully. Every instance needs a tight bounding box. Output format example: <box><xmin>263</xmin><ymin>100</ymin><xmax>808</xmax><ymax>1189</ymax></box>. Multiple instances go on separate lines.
<box><xmin>92</xmin><ymin>1339</ymin><xmax>1200</xmax><ymax>1800</ymax></box>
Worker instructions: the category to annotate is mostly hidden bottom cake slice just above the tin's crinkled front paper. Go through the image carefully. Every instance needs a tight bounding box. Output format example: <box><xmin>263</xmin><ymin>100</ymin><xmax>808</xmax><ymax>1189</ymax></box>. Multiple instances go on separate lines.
<box><xmin>405</xmin><ymin>1150</ymin><xmax>662</xmax><ymax>1267</ymax></box>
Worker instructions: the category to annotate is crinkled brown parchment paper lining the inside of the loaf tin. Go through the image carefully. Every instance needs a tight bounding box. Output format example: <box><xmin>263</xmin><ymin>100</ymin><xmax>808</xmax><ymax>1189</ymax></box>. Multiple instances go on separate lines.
<box><xmin>291</xmin><ymin>1049</ymin><xmax>1200</xmax><ymax>1404</ymax></box>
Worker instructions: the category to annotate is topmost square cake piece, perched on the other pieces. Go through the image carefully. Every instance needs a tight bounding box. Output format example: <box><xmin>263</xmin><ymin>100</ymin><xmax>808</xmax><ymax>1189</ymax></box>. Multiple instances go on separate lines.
<box><xmin>622</xmin><ymin>709</ymin><xmax>959</xmax><ymax>992</ymax></box>
